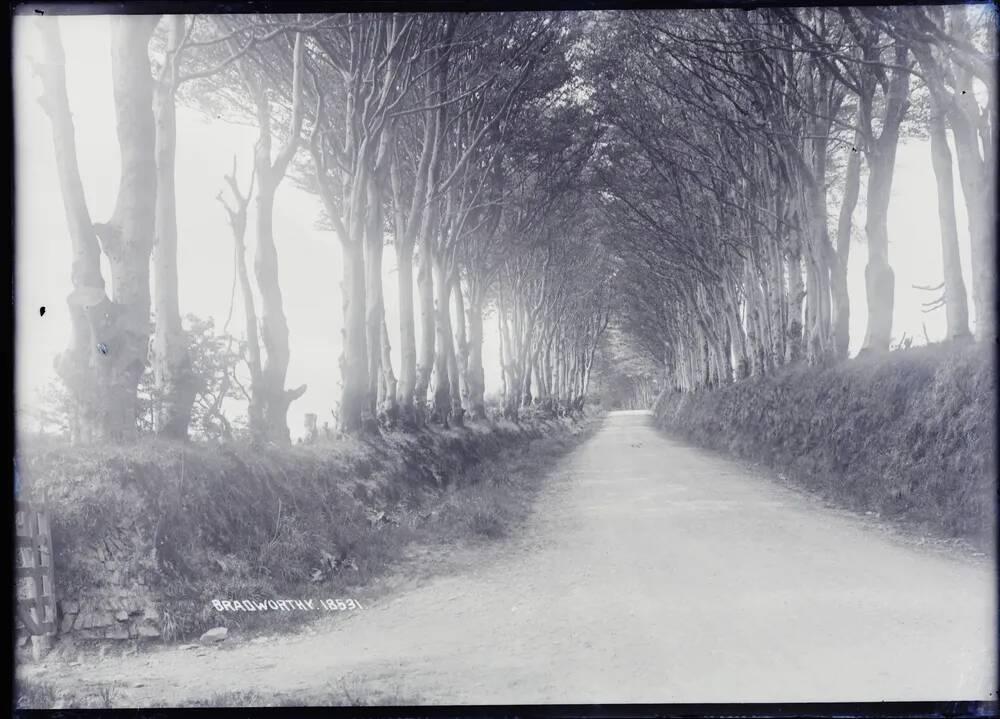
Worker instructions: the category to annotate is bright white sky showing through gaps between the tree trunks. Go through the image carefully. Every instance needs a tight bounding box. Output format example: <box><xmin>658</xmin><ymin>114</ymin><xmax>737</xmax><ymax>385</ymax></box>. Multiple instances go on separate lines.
<box><xmin>13</xmin><ymin>15</ymin><xmax>974</xmax><ymax>437</ymax></box>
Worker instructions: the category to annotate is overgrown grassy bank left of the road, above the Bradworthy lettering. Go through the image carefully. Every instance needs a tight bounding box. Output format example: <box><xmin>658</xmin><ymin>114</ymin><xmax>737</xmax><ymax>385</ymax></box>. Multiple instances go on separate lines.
<box><xmin>18</xmin><ymin>410</ymin><xmax>594</xmax><ymax>652</ymax></box>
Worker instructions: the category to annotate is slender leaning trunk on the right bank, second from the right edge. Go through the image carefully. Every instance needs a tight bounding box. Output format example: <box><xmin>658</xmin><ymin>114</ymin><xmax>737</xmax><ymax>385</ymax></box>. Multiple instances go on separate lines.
<box><xmin>929</xmin><ymin>99</ymin><xmax>970</xmax><ymax>339</ymax></box>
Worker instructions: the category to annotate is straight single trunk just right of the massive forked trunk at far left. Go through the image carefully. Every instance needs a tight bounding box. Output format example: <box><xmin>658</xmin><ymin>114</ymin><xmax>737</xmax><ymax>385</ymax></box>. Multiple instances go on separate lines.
<box><xmin>152</xmin><ymin>15</ymin><xmax>198</xmax><ymax>439</ymax></box>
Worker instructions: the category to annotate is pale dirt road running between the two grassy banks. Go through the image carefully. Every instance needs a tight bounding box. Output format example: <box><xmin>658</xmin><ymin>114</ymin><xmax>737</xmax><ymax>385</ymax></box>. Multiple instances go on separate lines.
<box><xmin>19</xmin><ymin>413</ymin><xmax>996</xmax><ymax>706</ymax></box>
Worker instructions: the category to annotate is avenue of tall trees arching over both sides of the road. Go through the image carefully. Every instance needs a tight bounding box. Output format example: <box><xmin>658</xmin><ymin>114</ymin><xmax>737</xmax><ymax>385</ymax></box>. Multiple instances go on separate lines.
<box><xmin>35</xmin><ymin>6</ymin><xmax>996</xmax><ymax>443</ymax></box>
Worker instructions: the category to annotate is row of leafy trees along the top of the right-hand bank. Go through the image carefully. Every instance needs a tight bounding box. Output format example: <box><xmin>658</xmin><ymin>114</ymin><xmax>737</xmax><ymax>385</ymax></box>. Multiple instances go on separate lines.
<box><xmin>581</xmin><ymin>7</ymin><xmax>993</xmax><ymax>376</ymax></box>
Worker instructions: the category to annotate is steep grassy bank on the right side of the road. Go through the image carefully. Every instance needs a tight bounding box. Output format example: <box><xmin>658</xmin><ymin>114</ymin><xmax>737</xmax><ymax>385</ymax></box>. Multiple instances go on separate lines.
<box><xmin>655</xmin><ymin>345</ymin><xmax>996</xmax><ymax>549</ymax></box>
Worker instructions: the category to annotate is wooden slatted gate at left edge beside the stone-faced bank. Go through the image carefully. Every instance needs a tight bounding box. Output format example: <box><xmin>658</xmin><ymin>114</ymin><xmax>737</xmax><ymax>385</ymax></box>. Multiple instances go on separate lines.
<box><xmin>14</xmin><ymin>501</ymin><xmax>56</xmax><ymax>637</ymax></box>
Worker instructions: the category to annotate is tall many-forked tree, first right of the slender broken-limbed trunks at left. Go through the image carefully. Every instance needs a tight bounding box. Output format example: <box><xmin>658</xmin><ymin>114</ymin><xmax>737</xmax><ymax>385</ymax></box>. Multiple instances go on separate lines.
<box><xmin>310</xmin><ymin>14</ymin><xmax>414</xmax><ymax>432</ymax></box>
